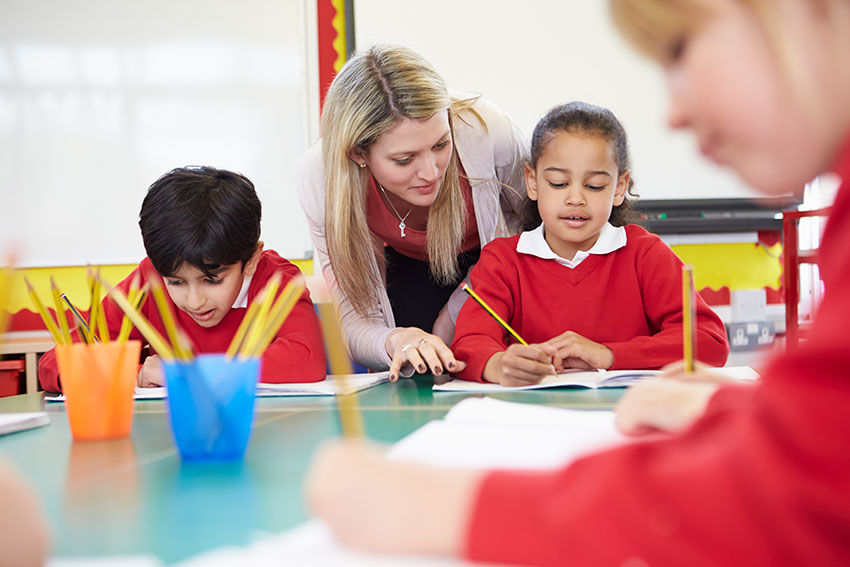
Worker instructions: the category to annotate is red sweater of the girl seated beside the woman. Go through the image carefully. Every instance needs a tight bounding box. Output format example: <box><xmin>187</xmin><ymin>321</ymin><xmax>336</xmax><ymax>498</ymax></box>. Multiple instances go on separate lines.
<box><xmin>452</xmin><ymin>225</ymin><xmax>729</xmax><ymax>380</ymax></box>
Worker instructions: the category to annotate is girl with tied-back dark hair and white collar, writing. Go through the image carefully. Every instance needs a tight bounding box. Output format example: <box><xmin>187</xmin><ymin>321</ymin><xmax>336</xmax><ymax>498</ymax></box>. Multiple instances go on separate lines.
<box><xmin>452</xmin><ymin>102</ymin><xmax>729</xmax><ymax>386</ymax></box>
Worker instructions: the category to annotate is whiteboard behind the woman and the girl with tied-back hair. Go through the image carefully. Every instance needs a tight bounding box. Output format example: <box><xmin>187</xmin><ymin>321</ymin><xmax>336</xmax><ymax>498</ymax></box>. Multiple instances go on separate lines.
<box><xmin>354</xmin><ymin>0</ymin><xmax>758</xmax><ymax>204</ymax></box>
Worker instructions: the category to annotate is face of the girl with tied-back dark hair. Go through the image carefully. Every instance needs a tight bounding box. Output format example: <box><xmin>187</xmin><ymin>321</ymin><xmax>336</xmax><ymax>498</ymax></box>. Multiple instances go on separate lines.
<box><xmin>525</xmin><ymin>131</ymin><xmax>629</xmax><ymax>260</ymax></box>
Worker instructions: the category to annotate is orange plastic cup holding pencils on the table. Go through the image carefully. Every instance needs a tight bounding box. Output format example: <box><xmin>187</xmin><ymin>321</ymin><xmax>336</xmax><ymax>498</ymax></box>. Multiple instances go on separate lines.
<box><xmin>56</xmin><ymin>341</ymin><xmax>141</xmax><ymax>440</ymax></box>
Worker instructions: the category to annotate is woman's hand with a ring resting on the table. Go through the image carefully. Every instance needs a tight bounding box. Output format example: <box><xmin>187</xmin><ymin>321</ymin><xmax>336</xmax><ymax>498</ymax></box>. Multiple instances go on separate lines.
<box><xmin>386</xmin><ymin>327</ymin><xmax>466</xmax><ymax>382</ymax></box>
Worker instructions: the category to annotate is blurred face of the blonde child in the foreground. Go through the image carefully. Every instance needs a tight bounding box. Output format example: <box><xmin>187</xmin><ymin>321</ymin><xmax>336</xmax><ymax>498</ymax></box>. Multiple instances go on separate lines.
<box><xmin>665</xmin><ymin>0</ymin><xmax>840</xmax><ymax>195</ymax></box>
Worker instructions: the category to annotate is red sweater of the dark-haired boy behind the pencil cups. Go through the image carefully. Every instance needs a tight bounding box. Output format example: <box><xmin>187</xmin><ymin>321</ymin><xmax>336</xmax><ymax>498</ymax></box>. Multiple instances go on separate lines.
<box><xmin>38</xmin><ymin>250</ymin><xmax>325</xmax><ymax>392</ymax></box>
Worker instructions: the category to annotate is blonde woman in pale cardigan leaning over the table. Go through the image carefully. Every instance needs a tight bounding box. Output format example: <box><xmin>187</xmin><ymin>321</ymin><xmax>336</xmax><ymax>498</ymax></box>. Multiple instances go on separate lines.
<box><xmin>298</xmin><ymin>45</ymin><xmax>527</xmax><ymax>380</ymax></box>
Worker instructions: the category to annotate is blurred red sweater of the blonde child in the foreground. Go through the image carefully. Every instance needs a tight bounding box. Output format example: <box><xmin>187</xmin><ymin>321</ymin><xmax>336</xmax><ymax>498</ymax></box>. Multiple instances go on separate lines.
<box><xmin>466</xmin><ymin>141</ymin><xmax>850</xmax><ymax>566</ymax></box>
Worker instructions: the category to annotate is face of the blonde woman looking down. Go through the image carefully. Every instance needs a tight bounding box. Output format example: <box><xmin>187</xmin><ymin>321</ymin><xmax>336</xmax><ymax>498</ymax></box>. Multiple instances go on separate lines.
<box><xmin>361</xmin><ymin>110</ymin><xmax>452</xmax><ymax>207</ymax></box>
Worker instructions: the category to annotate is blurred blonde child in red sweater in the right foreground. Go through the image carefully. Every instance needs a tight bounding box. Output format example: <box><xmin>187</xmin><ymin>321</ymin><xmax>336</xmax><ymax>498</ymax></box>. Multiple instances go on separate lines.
<box><xmin>308</xmin><ymin>0</ymin><xmax>850</xmax><ymax>566</ymax></box>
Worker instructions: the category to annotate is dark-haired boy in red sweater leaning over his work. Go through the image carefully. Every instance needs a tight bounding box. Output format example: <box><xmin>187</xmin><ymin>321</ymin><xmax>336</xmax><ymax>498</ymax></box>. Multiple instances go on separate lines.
<box><xmin>38</xmin><ymin>167</ymin><xmax>325</xmax><ymax>392</ymax></box>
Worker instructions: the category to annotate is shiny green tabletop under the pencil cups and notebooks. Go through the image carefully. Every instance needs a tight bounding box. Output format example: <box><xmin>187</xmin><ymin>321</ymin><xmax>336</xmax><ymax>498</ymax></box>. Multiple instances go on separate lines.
<box><xmin>0</xmin><ymin>376</ymin><xmax>622</xmax><ymax>563</ymax></box>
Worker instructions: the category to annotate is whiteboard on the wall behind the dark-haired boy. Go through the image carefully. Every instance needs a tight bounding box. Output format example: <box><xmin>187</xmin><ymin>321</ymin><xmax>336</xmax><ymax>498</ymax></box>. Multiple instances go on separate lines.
<box><xmin>0</xmin><ymin>0</ymin><xmax>317</xmax><ymax>266</ymax></box>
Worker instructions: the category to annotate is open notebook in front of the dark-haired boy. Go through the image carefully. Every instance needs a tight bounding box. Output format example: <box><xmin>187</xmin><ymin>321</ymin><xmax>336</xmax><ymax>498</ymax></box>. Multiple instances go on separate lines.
<box><xmin>44</xmin><ymin>372</ymin><xmax>390</xmax><ymax>402</ymax></box>
